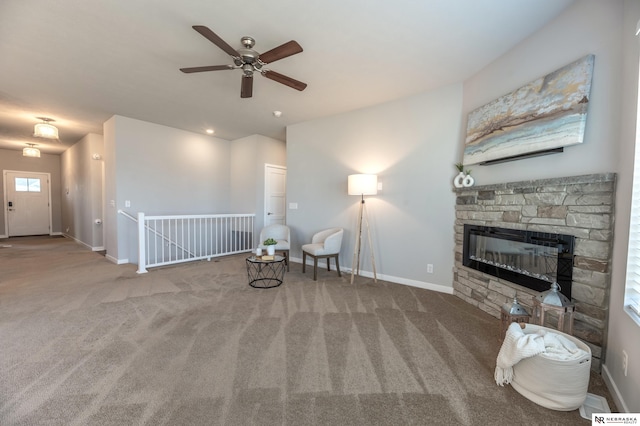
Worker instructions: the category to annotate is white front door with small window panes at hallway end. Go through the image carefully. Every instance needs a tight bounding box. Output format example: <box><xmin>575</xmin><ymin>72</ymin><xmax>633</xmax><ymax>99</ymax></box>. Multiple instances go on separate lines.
<box><xmin>4</xmin><ymin>171</ymin><xmax>51</xmax><ymax>237</ymax></box>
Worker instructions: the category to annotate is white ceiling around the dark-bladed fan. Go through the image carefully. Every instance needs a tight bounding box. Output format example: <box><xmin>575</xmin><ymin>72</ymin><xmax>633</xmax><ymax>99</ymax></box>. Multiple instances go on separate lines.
<box><xmin>0</xmin><ymin>0</ymin><xmax>573</xmax><ymax>153</ymax></box>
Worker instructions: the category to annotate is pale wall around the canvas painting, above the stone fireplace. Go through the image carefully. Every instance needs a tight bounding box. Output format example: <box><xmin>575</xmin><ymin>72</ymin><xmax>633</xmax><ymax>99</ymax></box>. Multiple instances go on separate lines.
<box><xmin>461</xmin><ymin>0</ymin><xmax>622</xmax><ymax>185</ymax></box>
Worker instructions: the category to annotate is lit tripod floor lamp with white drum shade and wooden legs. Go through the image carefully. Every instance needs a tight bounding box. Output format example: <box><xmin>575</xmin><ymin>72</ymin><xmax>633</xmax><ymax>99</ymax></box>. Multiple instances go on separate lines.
<box><xmin>347</xmin><ymin>174</ymin><xmax>378</xmax><ymax>284</ymax></box>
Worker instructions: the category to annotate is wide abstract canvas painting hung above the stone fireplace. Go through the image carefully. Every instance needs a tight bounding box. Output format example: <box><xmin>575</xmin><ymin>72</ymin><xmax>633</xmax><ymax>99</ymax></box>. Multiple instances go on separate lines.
<box><xmin>463</xmin><ymin>55</ymin><xmax>594</xmax><ymax>165</ymax></box>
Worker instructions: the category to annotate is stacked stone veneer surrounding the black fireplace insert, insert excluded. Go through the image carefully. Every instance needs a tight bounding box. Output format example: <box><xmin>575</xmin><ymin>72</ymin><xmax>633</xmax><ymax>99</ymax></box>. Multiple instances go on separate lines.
<box><xmin>453</xmin><ymin>173</ymin><xmax>616</xmax><ymax>370</ymax></box>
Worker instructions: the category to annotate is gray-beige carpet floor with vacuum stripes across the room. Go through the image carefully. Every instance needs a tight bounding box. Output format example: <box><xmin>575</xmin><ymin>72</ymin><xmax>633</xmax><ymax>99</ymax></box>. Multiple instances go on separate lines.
<box><xmin>0</xmin><ymin>237</ymin><xmax>613</xmax><ymax>425</ymax></box>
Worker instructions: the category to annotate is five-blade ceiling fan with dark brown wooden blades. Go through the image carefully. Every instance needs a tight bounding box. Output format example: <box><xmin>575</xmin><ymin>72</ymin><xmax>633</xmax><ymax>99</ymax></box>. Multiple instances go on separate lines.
<box><xmin>180</xmin><ymin>25</ymin><xmax>307</xmax><ymax>98</ymax></box>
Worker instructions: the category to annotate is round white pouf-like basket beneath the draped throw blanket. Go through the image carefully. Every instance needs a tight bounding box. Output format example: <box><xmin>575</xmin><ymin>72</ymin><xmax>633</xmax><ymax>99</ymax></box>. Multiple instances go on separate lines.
<box><xmin>511</xmin><ymin>324</ymin><xmax>591</xmax><ymax>411</ymax></box>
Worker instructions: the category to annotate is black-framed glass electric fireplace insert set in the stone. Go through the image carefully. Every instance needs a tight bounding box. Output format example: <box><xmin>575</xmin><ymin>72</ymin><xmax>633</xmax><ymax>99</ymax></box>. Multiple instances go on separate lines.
<box><xmin>462</xmin><ymin>224</ymin><xmax>575</xmax><ymax>299</ymax></box>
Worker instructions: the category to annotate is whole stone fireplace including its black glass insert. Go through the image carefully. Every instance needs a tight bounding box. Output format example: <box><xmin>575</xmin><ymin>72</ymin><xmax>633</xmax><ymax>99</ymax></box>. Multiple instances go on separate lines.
<box><xmin>453</xmin><ymin>173</ymin><xmax>615</xmax><ymax>369</ymax></box>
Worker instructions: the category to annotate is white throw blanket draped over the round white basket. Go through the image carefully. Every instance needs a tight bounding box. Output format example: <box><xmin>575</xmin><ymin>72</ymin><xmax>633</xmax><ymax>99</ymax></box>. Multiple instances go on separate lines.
<box><xmin>494</xmin><ymin>322</ymin><xmax>585</xmax><ymax>386</ymax></box>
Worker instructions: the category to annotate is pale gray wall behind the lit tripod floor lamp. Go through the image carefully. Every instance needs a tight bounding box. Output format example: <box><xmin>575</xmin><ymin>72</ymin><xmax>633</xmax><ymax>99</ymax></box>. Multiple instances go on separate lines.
<box><xmin>287</xmin><ymin>85</ymin><xmax>462</xmax><ymax>292</ymax></box>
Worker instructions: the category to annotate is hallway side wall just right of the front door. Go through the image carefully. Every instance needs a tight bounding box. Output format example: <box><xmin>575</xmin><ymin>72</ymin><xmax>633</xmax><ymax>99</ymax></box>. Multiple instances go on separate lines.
<box><xmin>60</xmin><ymin>133</ymin><xmax>104</xmax><ymax>250</ymax></box>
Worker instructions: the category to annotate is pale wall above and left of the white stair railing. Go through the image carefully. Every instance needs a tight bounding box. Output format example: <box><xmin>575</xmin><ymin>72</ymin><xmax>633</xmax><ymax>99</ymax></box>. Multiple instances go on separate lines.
<box><xmin>104</xmin><ymin>116</ymin><xmax>230</xmax><ymax>263</ymax></box>
